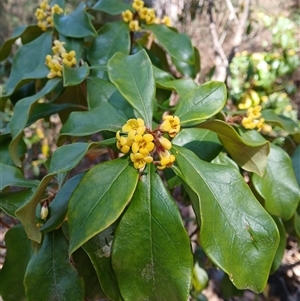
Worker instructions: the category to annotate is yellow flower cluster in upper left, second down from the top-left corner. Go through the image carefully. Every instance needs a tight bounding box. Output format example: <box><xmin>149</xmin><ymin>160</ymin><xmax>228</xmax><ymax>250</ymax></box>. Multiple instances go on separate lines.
<box><xmin>45</xmin><ymin>40</ymin><xmax>76</xmax><ymax>78</ymax></box>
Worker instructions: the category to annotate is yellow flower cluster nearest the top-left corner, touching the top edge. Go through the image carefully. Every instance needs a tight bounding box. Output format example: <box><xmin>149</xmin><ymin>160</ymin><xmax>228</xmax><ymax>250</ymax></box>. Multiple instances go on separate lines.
<box><xmin>35</xmin><ymin>0</ymin><xmax>64</xmax><ymax>31</ymax></box>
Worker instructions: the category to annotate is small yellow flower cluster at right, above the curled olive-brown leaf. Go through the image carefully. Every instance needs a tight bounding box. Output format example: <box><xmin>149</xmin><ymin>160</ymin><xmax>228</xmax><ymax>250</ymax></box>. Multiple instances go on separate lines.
<box><xmin>242</xmin><ymin>106</ymin><xmax>272</xmax><ymax>133</ymax></box>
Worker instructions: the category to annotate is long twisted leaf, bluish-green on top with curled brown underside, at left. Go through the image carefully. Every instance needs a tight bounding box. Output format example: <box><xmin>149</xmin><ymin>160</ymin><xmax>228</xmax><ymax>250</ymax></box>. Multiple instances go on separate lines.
<box><xmin>16</xmin><ymin>143</ymin><xmax>95</xmax><ymax>243</ymax></box>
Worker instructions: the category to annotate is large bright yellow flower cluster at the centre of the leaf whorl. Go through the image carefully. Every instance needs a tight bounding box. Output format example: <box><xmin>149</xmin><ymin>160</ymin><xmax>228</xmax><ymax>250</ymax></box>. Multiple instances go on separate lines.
<box><xmin>116</xmin><ymin>115</ymin><xmax>180</xmax><ymax>170</ymax></box>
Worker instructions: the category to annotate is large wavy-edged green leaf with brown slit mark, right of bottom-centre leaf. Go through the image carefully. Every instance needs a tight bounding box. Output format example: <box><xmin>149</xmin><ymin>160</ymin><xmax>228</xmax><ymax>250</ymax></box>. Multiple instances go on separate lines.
<box><xmin>173</xmin><ymin>146</ymin><xmax>279</xmax><ymax>293</ymax></box>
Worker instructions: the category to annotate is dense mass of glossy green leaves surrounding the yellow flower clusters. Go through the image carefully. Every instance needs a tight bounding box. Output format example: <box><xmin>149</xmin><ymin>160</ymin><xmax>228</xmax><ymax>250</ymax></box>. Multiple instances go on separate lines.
<box><xmin>0</xmin><ymin>0</ymin><xmax>300</xmax><ymax>301</ymax></box>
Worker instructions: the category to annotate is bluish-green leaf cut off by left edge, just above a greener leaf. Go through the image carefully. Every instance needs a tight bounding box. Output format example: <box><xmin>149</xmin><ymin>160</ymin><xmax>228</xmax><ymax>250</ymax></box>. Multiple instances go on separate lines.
<box><xmin>0</xmin><ymin>163</ymin><xmax>39</xmax><ymax>190</ymax></box>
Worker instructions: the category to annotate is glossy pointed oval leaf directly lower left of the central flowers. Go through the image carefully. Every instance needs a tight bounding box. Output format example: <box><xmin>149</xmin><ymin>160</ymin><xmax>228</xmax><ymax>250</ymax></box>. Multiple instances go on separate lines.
<box><xmin>68</xmin><ymin>158</ymin><xmax>138</xmax><ymax>254</ymax></box>
